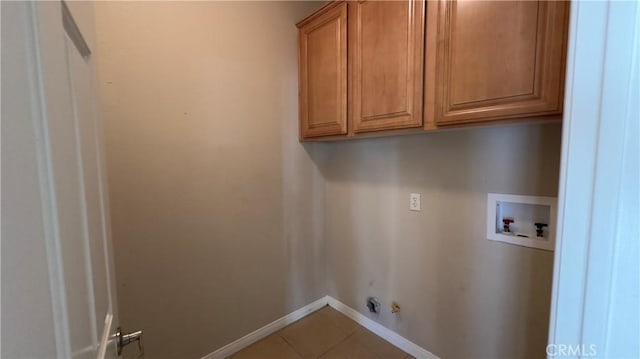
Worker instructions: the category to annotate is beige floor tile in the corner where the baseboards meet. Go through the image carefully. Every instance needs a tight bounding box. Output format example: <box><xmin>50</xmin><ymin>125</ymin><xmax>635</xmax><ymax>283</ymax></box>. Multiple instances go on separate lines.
<box><xmin>278</xmin><ymin>308</ymin><xmax>355</xmax><ymax>358</ymax></box>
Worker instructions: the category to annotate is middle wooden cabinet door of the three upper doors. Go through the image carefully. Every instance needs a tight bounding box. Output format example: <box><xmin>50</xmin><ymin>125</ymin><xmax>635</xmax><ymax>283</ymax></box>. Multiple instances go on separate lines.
<box><xmin>349</xmin><ymin>0</ymin><xmax>425</xmax><ymax>132</ymax></box>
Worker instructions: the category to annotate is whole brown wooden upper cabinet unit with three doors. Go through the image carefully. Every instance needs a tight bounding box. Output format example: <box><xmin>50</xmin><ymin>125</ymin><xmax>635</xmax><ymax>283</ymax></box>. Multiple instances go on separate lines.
<box><xmin>298</xmin><ymin>0</ymin><xmax>569</xmax><ymax>140</ymax></box>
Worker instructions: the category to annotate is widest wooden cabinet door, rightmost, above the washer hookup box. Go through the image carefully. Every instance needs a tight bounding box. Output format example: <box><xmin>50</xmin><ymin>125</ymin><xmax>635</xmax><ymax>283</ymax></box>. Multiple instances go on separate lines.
<box><xmin>435</xmin><ymin>1</ymin><xmax>568</xmax><ymax>125</ymax></box>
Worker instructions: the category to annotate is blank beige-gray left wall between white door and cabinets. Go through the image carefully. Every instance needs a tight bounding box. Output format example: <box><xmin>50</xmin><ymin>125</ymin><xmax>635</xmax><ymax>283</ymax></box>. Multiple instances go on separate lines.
<box><xmin>91</xmin><ymin>2</ymin><xmax>326</xmax><ymax>358</ymax></box>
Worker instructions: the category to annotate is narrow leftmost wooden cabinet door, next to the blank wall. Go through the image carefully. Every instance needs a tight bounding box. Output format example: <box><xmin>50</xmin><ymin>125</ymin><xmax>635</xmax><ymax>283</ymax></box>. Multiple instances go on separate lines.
<box><xmin>298</xmin><ymin>3</ymin><xmax>347</xmax><ymax>139</ymax></box>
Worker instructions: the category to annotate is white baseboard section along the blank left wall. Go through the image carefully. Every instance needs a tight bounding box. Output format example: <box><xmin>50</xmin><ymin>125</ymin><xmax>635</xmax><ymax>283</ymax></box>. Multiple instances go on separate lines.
<box><xmin>202</xmin><ymin>297</ymin><xmax>327</xmax><ymax>359</ymax></box>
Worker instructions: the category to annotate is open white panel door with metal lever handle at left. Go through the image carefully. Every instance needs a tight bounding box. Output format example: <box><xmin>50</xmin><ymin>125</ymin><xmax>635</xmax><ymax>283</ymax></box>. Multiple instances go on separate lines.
<box><xmin>2</xmin><ymin>1</ymin><xmax>128</xmax><ymax>358</ymax></box>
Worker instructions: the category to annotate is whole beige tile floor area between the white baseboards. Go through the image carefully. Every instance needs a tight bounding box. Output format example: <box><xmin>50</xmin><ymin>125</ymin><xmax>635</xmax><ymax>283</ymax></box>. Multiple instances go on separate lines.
<box><xmin>231</xmin><ymin>307</ymin><xmax>412</xmax><ymax>359</ymax></box>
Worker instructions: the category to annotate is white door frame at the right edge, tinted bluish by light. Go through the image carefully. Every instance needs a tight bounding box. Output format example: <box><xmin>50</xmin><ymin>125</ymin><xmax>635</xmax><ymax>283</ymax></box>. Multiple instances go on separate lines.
<box><xmin>547</xmin><ymin>1</ymin><xmax>640</xmax><ymax>358</ymax></box>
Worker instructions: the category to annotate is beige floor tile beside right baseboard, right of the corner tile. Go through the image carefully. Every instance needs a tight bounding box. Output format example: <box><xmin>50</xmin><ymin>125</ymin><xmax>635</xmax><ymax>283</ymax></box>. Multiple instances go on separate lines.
<box><xmin>321</xmin><ymin>328</ymin><xmax>407</xmax><ymax>359</ymax></box>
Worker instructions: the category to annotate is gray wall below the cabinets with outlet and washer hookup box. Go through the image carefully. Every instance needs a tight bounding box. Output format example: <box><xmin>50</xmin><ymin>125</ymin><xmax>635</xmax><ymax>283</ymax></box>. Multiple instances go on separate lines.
<box><xmin>322</xmin><ymin>124</ymin><xmax>561</xmax><ymax>358</ymax></box>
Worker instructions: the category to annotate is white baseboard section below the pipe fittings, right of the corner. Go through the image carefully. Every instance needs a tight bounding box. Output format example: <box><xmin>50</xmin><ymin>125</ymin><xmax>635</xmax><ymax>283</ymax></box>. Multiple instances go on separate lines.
<box><xmin>327</xmin><ymin>296</ymin><xmax>439</xmax><ymax>359</ymax></box>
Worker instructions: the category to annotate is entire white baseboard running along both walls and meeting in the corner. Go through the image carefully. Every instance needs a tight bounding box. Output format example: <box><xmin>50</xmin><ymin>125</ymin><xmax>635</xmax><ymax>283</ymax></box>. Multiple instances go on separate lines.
<box><xmin>202</xmin><ymin>296</ymin><xmax>439</xmax><ymax>359</ymax></box>
